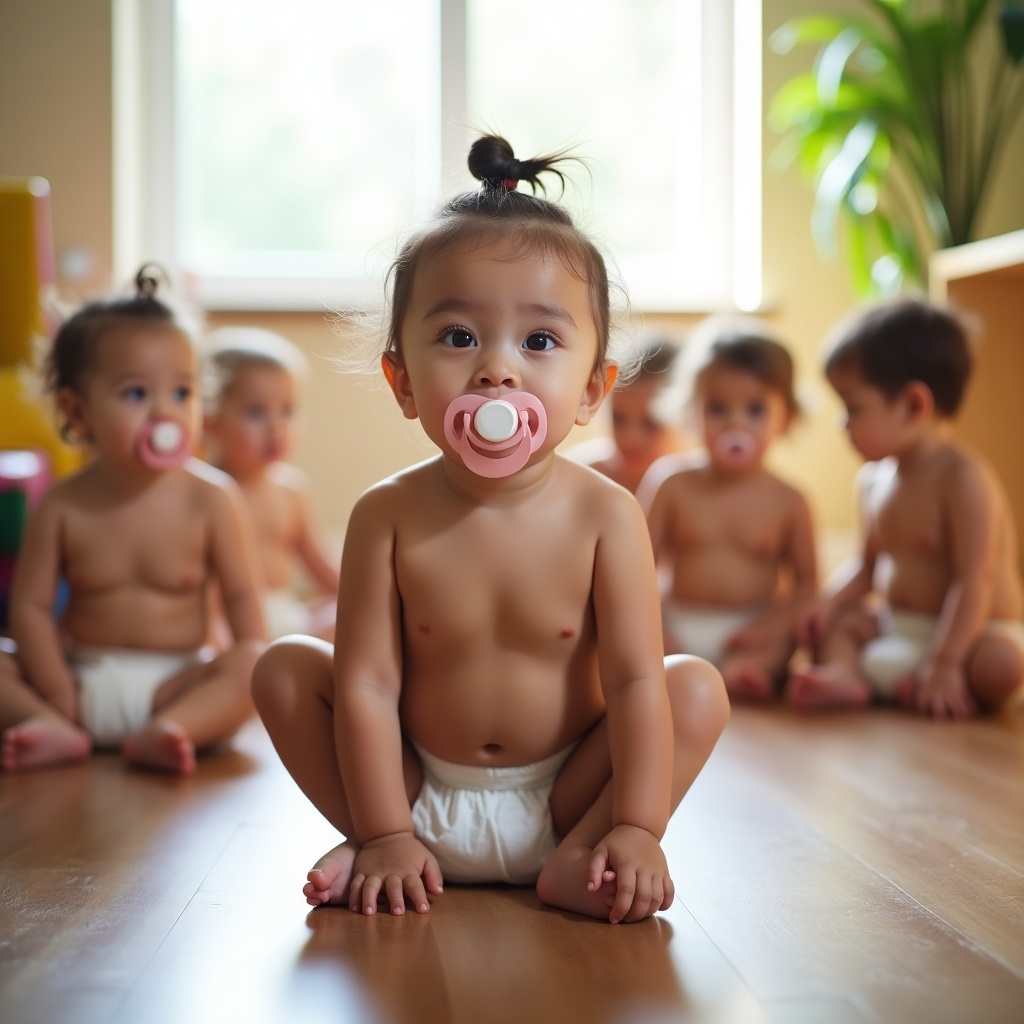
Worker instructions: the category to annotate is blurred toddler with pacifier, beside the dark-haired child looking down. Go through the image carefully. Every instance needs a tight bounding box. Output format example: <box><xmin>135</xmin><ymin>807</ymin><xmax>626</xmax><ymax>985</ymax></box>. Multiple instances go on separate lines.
<box><xmin>638</xmin><ymin>318</ymin><xmax>816</xmax><ymax>699</ymax></box>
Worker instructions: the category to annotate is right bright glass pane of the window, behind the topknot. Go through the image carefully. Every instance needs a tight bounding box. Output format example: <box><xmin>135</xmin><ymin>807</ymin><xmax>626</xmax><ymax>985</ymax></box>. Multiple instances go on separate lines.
<box><xmin>466</xmin><ymin>0</ymin><xmax>701</xmax><ymax>280</ymax></box>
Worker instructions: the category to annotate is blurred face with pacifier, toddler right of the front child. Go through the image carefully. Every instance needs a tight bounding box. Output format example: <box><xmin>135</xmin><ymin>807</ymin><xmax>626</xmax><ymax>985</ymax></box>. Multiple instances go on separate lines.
<box><xmin>696</xmin><ymin>367</ymin><xmax>790</xmax><ymax>472</ymax></box>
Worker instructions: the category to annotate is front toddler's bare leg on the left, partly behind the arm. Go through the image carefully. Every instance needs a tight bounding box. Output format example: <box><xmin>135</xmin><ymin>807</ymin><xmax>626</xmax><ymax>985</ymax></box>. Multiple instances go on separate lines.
<box><xmin>253</xmin><ymin>636</ymin><xmax>423</xmax><ymax>906</ymax></box>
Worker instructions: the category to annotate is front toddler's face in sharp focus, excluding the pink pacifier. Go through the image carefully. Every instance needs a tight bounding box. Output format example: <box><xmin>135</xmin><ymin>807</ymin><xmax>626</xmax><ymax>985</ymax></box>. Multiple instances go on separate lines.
<box><xmin>391</xmin><ymin>237</ymin><xmax>603</xmax><ymax>466</ymax></box>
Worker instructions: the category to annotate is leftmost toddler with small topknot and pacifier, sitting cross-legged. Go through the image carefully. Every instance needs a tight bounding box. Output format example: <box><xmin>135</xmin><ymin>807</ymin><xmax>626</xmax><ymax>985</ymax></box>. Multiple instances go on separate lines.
<box><xmin>0</xmin><ymin>267</ymin><xmax>263</xmax><ymax>774</ymax></box>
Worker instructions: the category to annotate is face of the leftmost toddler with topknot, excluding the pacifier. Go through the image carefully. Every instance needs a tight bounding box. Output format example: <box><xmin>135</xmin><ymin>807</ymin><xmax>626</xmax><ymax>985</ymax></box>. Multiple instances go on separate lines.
<box><xmin>60</xmin><ymin>323</ymin><xmax>200</xmax><ymax>469</ymax></box>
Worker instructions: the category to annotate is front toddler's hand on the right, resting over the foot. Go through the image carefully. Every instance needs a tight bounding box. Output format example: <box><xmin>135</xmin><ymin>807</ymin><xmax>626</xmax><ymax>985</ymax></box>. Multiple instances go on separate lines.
<box><xmin>587</xmin><ymin>825</ymin><xmax>676</xmax><ymax>925</ymax></box>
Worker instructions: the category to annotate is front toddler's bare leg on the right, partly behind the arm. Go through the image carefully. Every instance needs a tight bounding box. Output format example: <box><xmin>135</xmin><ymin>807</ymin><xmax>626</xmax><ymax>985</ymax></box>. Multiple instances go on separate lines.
<box><xmin>537</xmin><ymin>655</ymin><xmax>729</xmax><ymax>920</ymax></box>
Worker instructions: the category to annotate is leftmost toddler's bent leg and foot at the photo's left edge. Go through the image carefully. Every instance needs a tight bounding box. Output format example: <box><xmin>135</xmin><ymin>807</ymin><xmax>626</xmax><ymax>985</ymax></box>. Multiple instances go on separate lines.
<box><xmin>0</xmin><ymin>653</ymin><xmax>92</xmax><ymax>771</ymax></box>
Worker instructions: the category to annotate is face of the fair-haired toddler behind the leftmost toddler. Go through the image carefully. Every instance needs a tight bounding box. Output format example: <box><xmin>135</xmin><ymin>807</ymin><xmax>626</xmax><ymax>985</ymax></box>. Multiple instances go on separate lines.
<box><xmin>206</xmin><ymin>364</ymin><xmax>296</xmax><ymax>475</ymax></box>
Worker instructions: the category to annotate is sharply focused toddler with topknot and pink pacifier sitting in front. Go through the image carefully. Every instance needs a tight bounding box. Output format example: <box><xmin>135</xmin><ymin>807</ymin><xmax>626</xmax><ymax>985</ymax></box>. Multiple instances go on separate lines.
<box><xmin>253</xmin><ymin>136</ymin><xmax>728</xmax><ymax>923</ymax></box>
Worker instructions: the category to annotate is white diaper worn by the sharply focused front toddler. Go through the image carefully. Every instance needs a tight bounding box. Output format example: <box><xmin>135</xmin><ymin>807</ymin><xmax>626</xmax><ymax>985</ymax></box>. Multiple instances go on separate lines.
<box><xmin>413</xmin><ymin>746</ymin><xmax>573</xmax><ymax>886</ymax></box>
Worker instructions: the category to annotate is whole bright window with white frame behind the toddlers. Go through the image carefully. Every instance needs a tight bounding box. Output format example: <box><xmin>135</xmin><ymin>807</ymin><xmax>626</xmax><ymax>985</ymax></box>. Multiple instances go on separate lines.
<box><xmin>115</xmin><ymin>0</ymin><xmax>761</xmax><ymax>311</ymax></box>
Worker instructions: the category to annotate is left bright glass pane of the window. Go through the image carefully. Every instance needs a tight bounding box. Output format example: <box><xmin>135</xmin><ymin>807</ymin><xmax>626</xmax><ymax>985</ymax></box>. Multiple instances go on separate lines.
<box><xmin>176</xmin><ymin>0</ymin><xmax>438</xmax><ymax>272</ymax></box>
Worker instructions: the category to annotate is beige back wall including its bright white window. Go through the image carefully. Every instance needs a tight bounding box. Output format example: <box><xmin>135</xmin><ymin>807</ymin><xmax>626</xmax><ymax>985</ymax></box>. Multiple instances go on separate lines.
<box><xmin>0</xmin><ymin>0</ymin><xmax>1024</xmax><ymax>568</ymax></box>
